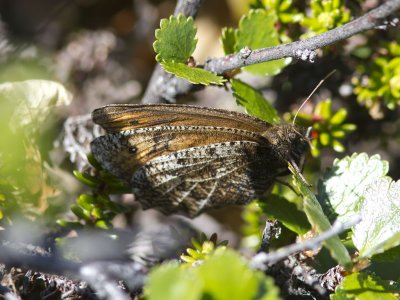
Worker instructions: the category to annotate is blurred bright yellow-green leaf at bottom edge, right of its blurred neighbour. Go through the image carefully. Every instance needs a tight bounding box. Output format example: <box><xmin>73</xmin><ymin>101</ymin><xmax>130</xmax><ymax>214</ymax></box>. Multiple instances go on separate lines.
<box><xmin>198</xmin><ymin>249</ymin><xmax>279</xmax><ymax>300</ymax></box>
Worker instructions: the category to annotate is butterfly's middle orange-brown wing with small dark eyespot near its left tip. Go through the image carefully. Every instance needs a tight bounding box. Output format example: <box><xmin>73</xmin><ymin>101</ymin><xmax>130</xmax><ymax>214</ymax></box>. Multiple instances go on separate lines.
<box><xmin>91</xmin><ymin>126</ymin><xmax>268</xmax><ymax>182</ymax></box>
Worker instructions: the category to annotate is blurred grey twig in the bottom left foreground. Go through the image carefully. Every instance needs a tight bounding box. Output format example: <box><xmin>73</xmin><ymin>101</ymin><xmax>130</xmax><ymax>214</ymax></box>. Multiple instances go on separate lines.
<box><xmin>0</xmin><ymin>245</ymin><xmax>148</xmax><ymax>300</ymax></box>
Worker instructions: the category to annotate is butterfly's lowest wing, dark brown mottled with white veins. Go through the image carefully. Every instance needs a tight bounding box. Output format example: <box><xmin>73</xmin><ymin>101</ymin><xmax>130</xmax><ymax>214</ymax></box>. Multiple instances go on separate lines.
<box><xmin>130</xmin><ymin>141</ymin><xmax>286</xmax><ymax>217</ymax></box>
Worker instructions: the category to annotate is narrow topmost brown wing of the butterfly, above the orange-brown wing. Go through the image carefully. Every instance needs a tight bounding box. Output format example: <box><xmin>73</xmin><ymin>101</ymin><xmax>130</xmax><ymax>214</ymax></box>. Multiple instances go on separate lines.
<box><xmin>92</xmin><ymin>104</ymin><xmax>272</xmax><ymax>133</ymax></box>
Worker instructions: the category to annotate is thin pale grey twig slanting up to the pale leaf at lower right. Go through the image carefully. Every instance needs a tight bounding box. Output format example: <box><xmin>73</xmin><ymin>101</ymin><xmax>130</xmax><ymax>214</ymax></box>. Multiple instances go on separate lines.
<box><xmin>250</xmin><ymin>216</ymin><xmax>361</xmax><ymax>271</ymax></box>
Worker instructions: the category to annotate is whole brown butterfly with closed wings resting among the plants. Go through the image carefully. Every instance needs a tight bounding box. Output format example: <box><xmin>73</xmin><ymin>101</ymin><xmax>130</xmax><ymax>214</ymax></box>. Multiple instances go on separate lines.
<box><xmin>91</xmin><ymin>104</ymin><xmax>309</xmax><ymax>217</ymax></box>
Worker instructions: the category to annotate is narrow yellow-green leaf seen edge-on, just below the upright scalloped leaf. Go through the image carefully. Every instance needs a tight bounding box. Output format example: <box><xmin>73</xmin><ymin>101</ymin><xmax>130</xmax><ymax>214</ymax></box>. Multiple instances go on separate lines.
<box><xmin>161</xmin><ymin>61</ymin><xmax>226</xmax><ymax>85</ymax></box>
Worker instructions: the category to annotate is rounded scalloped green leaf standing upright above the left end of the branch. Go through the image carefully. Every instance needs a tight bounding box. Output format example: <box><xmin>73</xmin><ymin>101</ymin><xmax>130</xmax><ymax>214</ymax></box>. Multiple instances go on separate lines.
<box><xmin>153</xmin><ymin>15</ymin><xmax>197</xmax><ymax>63</ymax></box>
